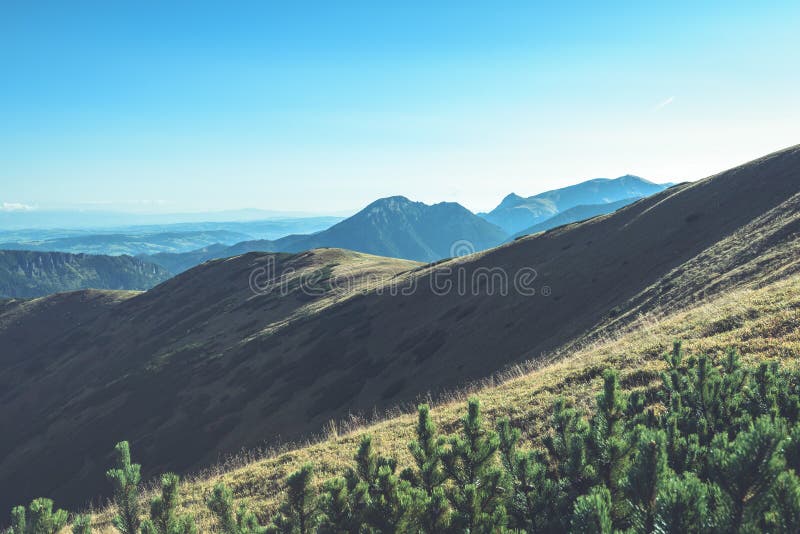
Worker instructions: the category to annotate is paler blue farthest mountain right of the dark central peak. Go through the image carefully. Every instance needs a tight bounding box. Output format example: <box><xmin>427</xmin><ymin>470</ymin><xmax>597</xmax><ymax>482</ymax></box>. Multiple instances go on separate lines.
<box><xmin>480</xmin><ymin>175</ymin><xmax>667</xmax><ymax>234</ymax></box>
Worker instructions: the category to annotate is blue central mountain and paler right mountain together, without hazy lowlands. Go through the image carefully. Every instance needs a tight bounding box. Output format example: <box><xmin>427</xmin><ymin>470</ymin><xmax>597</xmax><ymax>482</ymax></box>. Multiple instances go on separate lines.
<box><xmin>147</xmin><ymin>176</ymin><xmax>666</xmax><ymax>273</ymax></box>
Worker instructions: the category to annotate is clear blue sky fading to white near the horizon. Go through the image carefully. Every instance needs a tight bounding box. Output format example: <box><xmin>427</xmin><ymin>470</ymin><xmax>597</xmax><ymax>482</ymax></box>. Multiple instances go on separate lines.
<box><xmin>0</xmin><ymin>0</ymin><xmax>800</xmax><ymax>218</ymax></box>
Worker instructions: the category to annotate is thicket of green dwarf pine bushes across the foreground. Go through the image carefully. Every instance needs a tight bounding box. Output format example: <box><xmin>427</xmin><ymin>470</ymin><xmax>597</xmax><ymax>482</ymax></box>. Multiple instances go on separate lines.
<box><xmin>7</xmin><ymin>344</ymin><xmax>800</xmax><ymax>534</ymax></box>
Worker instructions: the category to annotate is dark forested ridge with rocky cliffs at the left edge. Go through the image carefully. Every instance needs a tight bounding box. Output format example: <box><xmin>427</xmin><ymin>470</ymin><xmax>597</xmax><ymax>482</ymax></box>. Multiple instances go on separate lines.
<box><xmin>0</xmin><ymin>250</ymin><xmax>170</xmax><ymax>298</ymax></box>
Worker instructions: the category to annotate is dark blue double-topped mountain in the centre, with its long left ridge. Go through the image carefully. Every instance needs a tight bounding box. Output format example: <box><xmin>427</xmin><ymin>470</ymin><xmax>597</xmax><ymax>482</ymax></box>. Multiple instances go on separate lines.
<box><xmin>150</xmin><ymin>196</ymin><xmax>507</xmax><ymax>273</ymax></box>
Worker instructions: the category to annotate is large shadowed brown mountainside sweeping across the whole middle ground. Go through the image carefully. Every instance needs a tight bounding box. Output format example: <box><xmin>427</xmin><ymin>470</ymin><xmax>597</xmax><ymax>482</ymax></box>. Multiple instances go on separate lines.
<box><xmin>0</xmin><ymin>146</ymin><xmax>800</xmax><ymax>508</ymax></box>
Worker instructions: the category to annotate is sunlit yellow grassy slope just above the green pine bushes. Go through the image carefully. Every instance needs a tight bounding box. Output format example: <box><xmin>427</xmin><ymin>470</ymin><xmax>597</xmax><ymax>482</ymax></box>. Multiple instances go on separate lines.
<box><xmin>86</xmin><ymin>275</ymin><xmax>800</xmax><ymax>532</ymax></box>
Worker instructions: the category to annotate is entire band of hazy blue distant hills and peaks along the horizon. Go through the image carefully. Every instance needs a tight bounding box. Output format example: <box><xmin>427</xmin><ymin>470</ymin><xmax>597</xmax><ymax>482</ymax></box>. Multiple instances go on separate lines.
<box><xmin>0</xmin><ymin>176</ymin><xmax>662</xmax><ymax>288</ymax></box>
